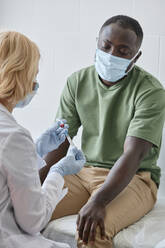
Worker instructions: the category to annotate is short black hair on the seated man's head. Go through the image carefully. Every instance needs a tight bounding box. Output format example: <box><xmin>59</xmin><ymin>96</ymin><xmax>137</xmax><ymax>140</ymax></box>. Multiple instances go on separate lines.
<box><xmin>101</xmin><ymin>15</ymin><xmax>143</xmax><ymax>47</ymax></box>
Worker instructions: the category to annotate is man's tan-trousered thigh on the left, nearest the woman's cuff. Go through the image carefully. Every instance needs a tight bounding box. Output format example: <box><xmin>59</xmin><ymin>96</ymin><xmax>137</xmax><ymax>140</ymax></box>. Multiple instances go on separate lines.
<box><xmin>51</xmin><ymin>175</ymin><xmax>90</xmax><ymax>220</ymax></box>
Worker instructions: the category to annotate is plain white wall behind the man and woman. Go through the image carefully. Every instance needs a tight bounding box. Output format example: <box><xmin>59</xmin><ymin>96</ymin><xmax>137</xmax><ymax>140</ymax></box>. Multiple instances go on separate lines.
<box><xmin>0</xmin><ymin>0</ymin><xmax>165</xmax><ymax>192</ymax></box>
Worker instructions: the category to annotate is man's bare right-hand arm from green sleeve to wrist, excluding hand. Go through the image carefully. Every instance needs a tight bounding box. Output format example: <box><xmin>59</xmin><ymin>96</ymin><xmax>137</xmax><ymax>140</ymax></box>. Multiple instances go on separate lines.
<box><xmin>91</xmin><ymin>137</ymin><xmax>153</xmax><ymax>206</ymax></box>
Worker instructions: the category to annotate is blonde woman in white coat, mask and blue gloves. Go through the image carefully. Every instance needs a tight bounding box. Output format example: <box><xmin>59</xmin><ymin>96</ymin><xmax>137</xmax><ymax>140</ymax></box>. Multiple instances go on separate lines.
<box><xmin>0</xmin><ymin>32</ymin><xmax>85</xmax><ymax>248</ymax></box>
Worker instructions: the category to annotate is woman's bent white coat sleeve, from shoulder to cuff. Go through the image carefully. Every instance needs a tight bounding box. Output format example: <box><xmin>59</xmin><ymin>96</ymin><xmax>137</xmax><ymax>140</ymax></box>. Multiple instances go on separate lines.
<box><xmin>1</xmin><ymin>130</ymin><xmax>64</xmax><ymax>234</ymax></box>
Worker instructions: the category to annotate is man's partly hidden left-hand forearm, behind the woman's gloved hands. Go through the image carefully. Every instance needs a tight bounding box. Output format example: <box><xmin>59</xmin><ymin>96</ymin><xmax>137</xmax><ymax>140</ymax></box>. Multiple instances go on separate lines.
<box><xmin>39</xmin><ymin>139</ymin><xmax>69</xmax><ymax>184</ymax></box>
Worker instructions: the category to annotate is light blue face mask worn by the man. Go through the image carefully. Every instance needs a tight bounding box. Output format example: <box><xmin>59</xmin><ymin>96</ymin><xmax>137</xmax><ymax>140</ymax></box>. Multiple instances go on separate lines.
<box><xmin>95</xmin><ymin>48</ymin><xmax>137</xmax><ymax>83</ymax></box>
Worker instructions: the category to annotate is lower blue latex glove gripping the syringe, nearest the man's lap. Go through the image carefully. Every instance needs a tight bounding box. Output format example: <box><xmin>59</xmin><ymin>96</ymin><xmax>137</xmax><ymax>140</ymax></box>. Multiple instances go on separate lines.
<box><xmin>49</xmin><ymin>146</ymin><xmax>86</xmax><ymax>176</ymax></box>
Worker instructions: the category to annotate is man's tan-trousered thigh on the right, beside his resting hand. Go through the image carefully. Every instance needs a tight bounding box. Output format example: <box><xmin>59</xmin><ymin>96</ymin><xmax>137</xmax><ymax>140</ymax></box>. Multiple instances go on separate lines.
<box><xmin>98</xmin><ymin>172</ymin><xmax>157</xmax><ymax>238</ymax></box>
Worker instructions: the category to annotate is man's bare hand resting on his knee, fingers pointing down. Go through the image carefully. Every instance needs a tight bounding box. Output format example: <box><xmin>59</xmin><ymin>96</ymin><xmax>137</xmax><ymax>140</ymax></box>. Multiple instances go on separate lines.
<box><xmin>77</xmin><ymin>200</ymin><xmax>105</xmax><ymax>244</ymax></box>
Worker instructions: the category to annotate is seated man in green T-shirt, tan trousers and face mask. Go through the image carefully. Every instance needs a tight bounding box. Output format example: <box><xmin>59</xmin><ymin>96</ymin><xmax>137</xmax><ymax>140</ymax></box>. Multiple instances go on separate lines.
<box><xmin>41</xmin><ymin>15</ymin><xmax>165</xmax><ymax>248</ymax></box>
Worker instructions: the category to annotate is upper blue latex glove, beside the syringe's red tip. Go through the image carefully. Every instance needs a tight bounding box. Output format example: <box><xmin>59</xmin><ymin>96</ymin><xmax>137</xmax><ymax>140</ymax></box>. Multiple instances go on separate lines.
<box><xmin>36</xmin><ymin>120</ymin><xmax>69</xmax><ymax>157</ymax></box>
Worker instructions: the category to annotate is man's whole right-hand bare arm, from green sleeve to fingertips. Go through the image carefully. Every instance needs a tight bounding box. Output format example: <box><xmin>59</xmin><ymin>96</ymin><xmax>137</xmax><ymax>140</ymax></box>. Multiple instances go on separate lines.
<box><xmin>77</xmin><ymin>137</ymin><xmax>152</xmax><ymax>244</ymax></box>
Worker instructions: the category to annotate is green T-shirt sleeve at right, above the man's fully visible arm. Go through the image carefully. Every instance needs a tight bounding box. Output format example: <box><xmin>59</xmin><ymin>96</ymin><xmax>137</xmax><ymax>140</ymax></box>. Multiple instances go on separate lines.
<box><xmin>127</xmin><ymin>89</ymin><xmax>165</xmax><ymax>147</ymax></box>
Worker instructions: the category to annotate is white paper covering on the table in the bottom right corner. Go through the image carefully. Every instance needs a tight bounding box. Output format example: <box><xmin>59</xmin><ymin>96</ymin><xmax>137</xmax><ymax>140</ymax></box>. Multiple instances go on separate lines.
<box><xmin>115</xmin><ymin>198</ymin><xmax>165</xmax><ymax>248</ymax></box>
